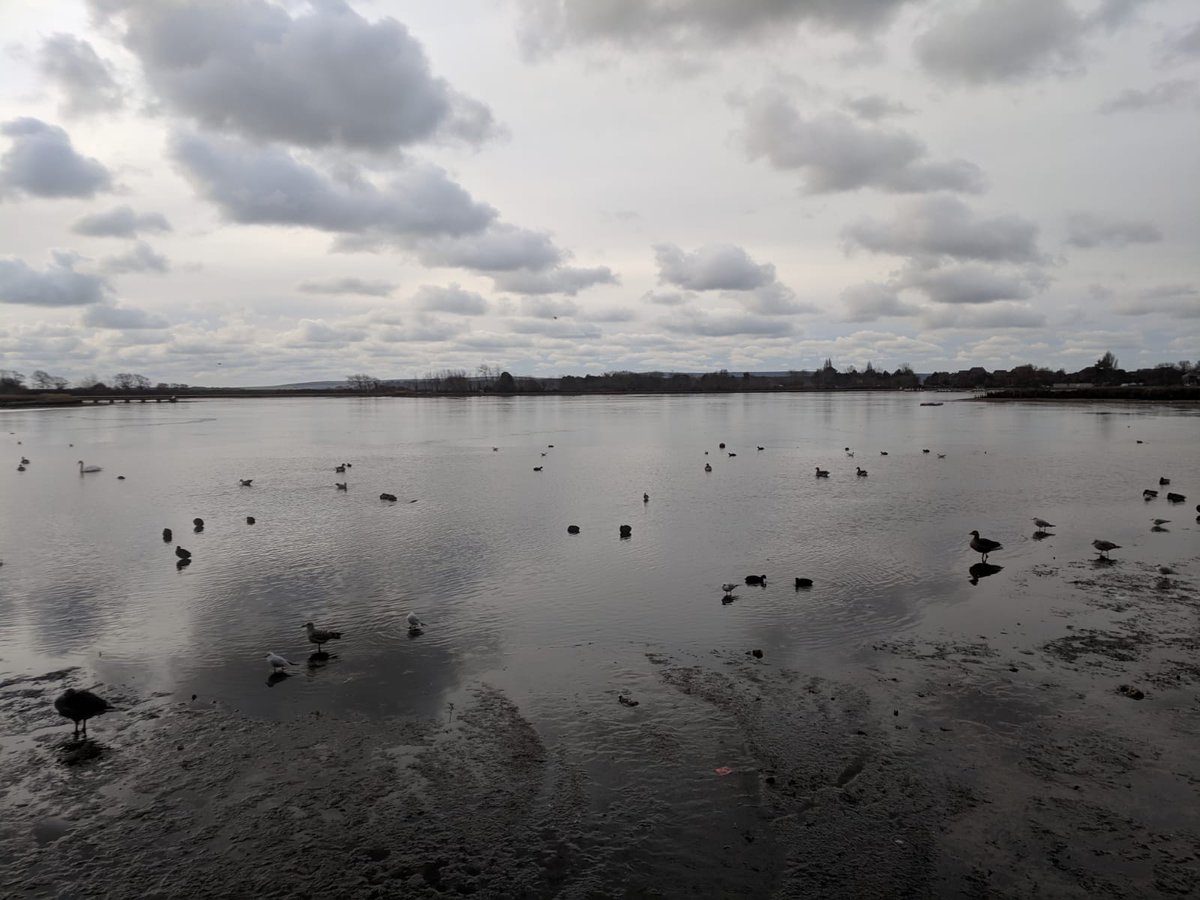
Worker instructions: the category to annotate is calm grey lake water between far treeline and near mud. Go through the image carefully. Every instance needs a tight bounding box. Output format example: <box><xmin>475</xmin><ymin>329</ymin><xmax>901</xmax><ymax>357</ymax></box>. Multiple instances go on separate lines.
<box><xmin>0</xmin><ymin>394</ymin><xmax>1200</xmax><ymax>720</ymax></box>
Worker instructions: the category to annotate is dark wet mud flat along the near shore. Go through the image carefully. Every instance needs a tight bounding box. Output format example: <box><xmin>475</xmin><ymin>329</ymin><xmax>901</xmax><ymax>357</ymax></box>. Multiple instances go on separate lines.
<box><xmin>0</xmin><ymin>560</ymin><xmax>1200</xmax><ymax>898</ymax></box>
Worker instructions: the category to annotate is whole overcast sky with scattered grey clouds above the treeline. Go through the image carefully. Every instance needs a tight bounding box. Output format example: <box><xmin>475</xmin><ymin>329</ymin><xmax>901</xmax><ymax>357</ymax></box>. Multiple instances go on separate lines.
<box><xmin>0</xmin><ymin>0</ymin><xmax>1200</xmax><ymax>385</ymax></box>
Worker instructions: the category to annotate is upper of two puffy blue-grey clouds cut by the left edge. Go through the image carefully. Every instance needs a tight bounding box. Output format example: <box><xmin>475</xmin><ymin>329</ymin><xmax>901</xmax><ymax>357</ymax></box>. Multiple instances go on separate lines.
<box><xmin>0</xmin><ymin>118</ymin><xmax>112</xmax><ymax>197</ymax></box>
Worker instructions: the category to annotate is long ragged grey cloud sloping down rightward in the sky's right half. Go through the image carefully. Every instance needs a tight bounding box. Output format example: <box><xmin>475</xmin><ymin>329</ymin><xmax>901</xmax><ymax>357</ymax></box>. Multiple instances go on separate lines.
<box><xmin>745</xmin><ymin>91</ymin><xmax>984</xmax><ymax>194</ymax></box>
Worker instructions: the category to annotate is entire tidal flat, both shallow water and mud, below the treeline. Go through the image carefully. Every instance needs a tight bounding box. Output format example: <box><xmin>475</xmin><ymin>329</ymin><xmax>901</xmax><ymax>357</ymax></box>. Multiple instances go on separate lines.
<box><xmin>0</xmin><ymin>395</ymin><xmax>1200</xmax><ymax>898</ymax></box>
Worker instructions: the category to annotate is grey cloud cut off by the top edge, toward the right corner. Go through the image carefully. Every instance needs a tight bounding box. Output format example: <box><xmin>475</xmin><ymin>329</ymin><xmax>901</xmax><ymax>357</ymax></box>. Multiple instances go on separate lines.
<box><xmin>914</xmin><ymin>0</ymin><xmax>1091</xmax><ymax>84</ymax></box>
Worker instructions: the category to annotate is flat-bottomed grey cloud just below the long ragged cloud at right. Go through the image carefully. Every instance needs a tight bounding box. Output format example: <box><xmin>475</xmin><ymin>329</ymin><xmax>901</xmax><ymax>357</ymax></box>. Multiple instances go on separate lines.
<box><xmin>844</xmin><ymin>196</ymin><xmax>1042</xmax><ymax>263</ymax></box>
